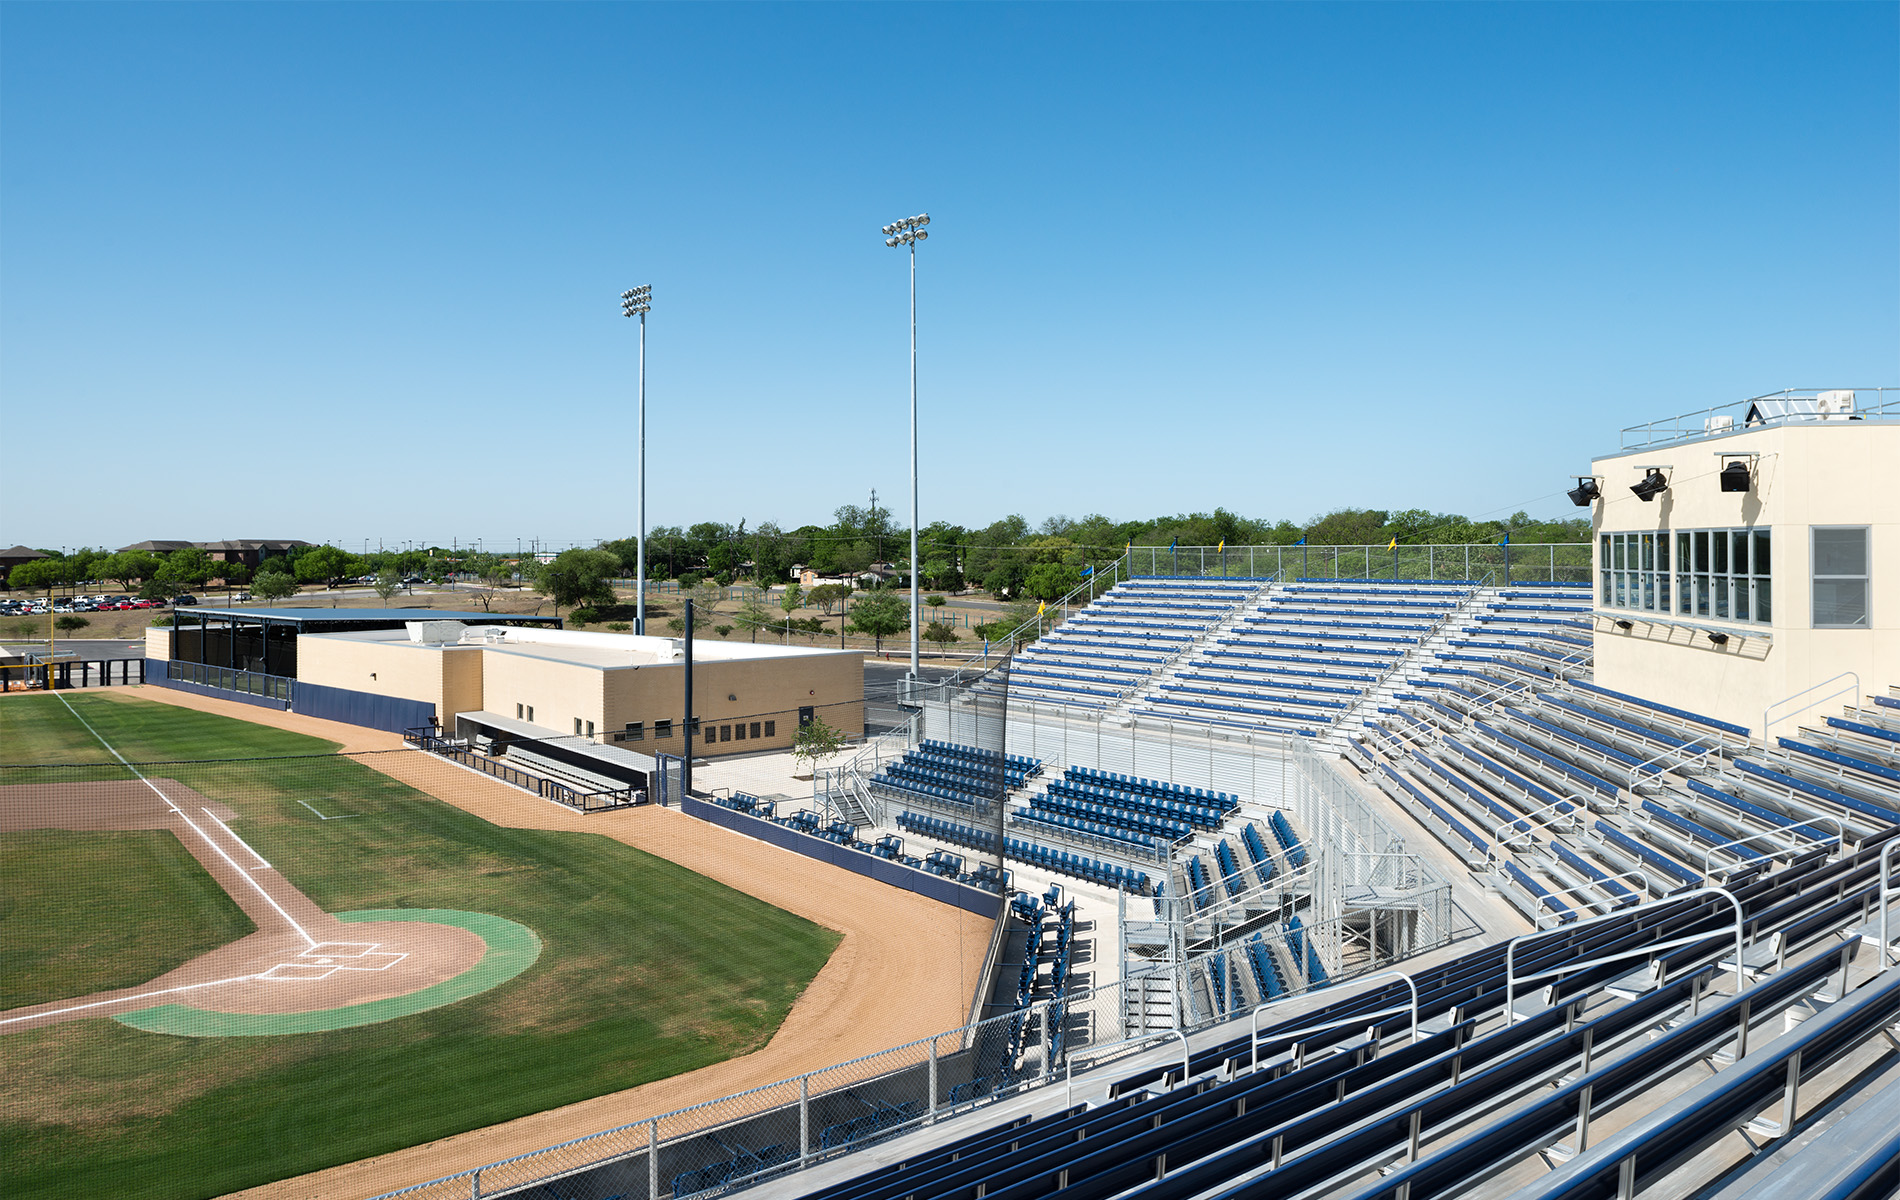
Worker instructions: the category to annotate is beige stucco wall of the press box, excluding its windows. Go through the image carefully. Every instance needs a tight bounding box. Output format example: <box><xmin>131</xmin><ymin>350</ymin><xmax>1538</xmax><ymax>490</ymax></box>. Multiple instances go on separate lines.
<box><xmin>1594</xmin><ymin>422</ymin><xmax>1900</xmax><ymax>733</ymax></box>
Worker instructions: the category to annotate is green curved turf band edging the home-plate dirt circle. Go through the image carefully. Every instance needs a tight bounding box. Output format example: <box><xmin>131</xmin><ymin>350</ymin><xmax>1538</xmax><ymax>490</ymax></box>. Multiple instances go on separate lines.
<box><xmin>112</xmin><ymin>908</ymin><xmax>542</xmax><ymax>1037</ymax></box>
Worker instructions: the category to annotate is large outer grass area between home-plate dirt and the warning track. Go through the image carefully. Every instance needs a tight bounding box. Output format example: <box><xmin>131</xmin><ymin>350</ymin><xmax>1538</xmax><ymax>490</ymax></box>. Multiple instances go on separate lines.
<box><xmin>0</xmin><ymin>693</ymin><xmax>838</xmax><ymax>1200</ymax></box>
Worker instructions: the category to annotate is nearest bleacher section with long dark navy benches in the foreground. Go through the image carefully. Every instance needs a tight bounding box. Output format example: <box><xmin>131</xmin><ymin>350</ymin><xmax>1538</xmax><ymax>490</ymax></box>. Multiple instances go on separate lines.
<box><xmin>790</xmin><ymin>830</ymin><xmax>1900</xmax><ymax>1200</ymax></box>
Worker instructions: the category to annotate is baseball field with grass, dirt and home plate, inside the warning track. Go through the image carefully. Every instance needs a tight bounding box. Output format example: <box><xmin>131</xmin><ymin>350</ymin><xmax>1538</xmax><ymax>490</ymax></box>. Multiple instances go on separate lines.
<box><xmin>0</xmin><ymin>691</ymin><xmax>840</xmax><ymax>1198</ymax></box>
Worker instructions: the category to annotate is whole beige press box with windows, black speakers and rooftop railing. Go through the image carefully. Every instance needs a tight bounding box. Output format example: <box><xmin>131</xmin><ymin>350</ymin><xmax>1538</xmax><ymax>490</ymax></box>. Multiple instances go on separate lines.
<box><xmin>1573</xmin><ymin>389</ymin><xmax>1900</xmax><ymax>733</ymax></box>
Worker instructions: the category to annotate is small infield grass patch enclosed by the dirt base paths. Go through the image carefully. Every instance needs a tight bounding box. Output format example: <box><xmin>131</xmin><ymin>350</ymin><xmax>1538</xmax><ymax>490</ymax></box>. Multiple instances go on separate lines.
<box><xmin>0</xmin><ymin>830</ymin><xmax>257</xmax><ymax>1008</ymax></box>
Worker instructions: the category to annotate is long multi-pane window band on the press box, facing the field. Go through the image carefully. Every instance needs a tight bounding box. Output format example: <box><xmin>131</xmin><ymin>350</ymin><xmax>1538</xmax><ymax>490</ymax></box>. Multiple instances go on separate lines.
<box><xmin>1596</xmin><ymin>530</ymin><xmax>1775</xmax><ymax>625</ymax></box>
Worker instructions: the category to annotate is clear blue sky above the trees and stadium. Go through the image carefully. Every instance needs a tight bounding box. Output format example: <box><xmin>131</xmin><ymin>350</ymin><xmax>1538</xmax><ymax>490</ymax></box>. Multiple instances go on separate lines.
<box><xmin>0</xmin><ymin>4</ymin><xmax>1900</xmax><ymax>547</ymax></box>
